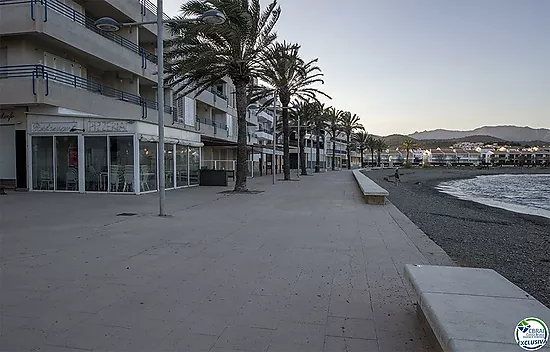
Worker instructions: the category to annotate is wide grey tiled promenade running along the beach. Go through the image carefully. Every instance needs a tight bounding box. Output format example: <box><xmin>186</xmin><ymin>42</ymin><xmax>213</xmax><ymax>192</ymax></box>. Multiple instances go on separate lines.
<box><xmin>0</xmin><ymin>171</ymin><xmax>448</xmax><ymax>352</ymax></box>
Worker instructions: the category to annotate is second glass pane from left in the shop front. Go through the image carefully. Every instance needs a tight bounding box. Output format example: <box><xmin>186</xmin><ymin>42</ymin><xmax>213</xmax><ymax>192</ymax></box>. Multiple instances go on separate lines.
<box><xmin>55</xmin><ymin>136</ymin><xmax>78</xmax><ymax>191</ymax></box>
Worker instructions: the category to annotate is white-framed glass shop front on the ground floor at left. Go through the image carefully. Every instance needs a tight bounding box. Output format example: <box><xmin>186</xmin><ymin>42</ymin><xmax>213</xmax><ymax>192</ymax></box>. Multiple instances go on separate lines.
<box><xmin>27</xmin><ymin>114</ymin><xmax>202</xmax><ymax>194</ymax></box>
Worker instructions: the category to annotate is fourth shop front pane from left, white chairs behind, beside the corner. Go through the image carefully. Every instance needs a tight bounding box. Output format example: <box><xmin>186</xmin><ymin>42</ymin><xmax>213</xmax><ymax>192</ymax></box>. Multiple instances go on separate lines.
<box><xmin>109</xmin><ymin>136</ymin><xmax>134</xmax><ymax>192</ymax></box>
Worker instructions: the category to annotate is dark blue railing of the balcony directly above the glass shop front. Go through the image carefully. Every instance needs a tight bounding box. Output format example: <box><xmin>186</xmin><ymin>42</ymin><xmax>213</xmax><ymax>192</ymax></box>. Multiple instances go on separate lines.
<box><xmin>0</xmin><ymin>65</ymin><xmax>175</xmax><ymax>118</ymax></box>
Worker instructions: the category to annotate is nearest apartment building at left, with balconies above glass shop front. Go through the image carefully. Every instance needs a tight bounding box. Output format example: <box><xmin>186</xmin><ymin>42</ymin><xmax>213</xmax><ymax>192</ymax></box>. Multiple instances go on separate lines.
<box><xmin>0</xmin><ymin>0</ymin><xmax>207</xmax><ymax>193</ymax></box>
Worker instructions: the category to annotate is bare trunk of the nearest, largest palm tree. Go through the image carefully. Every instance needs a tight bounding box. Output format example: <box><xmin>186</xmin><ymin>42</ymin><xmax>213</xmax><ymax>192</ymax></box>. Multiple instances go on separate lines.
<box><xmin>234</xmin><ymin>80</ymin><xmax>248</xmax><ymax>192</ymax></box>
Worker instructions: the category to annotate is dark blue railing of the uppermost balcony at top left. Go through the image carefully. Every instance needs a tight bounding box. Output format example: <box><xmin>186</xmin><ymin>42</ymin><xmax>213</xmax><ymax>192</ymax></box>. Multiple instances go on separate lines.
<box><xmin>0</xmin><ymin>0</ymin><xmax>157</xmax><ymax>68</ymax></box>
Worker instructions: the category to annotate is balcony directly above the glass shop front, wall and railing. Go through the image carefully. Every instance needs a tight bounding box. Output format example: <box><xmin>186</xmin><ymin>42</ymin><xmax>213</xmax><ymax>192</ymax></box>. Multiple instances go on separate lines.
<box><xmin>0</xmin><ymin>65</ymin><xmax>176</xmax><ymax>123</ymax></box>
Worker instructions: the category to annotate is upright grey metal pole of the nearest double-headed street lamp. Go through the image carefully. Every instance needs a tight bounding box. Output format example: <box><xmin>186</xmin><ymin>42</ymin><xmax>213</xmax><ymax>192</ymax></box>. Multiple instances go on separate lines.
<box><xmin>157</xmin><ymin>0</ymin><xmax>166</xmax><ymax>216</ymax></box>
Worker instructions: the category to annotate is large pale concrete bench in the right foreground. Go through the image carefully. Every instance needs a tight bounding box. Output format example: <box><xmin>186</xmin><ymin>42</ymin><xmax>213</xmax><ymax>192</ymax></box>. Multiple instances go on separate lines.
<box><xmin>405</xmin><ymin>264</ymin><xmax>550</xmax><ymax>352</ymax></box>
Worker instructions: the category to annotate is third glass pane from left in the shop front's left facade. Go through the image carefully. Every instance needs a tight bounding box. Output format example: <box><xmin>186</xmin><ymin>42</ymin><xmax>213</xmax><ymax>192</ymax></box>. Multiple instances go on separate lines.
<box><xmin>84</xmin><ymin>136</ymin><xmax>109</xmax><ymax>192</ymax></box>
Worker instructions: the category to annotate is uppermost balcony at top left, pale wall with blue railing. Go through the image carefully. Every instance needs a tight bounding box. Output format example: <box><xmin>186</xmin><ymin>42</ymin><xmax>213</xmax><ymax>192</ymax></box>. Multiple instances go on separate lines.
<box><xmin>0</xmin><ymin>0</ymin><xmax>157</xmax><ymax>81</ymax></box>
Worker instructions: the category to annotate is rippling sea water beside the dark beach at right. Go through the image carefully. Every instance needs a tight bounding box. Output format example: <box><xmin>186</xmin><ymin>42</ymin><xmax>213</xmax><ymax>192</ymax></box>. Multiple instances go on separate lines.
<box><xmin>436</xmin><ymin>174</ymin><xmax>550</xmax><ymax>218</ymax></box>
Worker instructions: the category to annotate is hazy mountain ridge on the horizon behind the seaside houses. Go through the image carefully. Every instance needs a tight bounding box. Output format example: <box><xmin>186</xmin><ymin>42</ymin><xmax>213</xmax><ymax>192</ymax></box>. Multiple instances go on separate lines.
<box><xmin>409</xmin><ymin>126</ymin><xmax>550</xmax><ymax>142</ymax></box>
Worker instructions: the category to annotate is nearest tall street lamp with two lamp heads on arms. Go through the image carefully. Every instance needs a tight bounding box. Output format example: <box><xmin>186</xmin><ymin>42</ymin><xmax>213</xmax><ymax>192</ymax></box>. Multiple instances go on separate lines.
<box><xmin>94</xmin><ymin>8</ymin><xmax>227</xmax><ymax>216</ymax></box>
